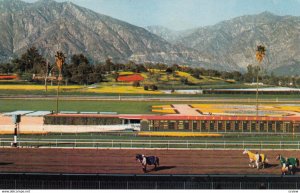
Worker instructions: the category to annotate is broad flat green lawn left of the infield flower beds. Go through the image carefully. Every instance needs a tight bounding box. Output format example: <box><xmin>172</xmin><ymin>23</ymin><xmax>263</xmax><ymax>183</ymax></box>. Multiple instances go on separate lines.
<box><xmin>0</xmin><ymin>99</ymin><xmax>188</xmax><ymax>114</ymax></box>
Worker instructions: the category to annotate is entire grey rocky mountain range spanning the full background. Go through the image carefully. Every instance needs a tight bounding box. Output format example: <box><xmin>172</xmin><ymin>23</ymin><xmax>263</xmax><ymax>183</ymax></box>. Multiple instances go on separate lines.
<box><xmin>0</xmin><ymin>0</ymin><xmax>300</xmax><ymax>74</ymax></box>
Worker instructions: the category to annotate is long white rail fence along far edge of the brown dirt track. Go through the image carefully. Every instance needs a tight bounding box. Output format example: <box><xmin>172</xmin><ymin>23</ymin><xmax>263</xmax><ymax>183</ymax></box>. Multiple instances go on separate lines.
<box><xmin>0</xmin><ymin>138</ymin><xmax>300</xmax><ymax>150</ymax></box>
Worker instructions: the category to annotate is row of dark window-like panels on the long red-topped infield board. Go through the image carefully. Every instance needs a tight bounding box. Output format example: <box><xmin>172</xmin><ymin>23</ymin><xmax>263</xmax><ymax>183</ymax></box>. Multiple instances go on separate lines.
<box><xmin>149</xmin><ymin>120</ymin><xmax>300</xmax><ymax>132</ymax></box>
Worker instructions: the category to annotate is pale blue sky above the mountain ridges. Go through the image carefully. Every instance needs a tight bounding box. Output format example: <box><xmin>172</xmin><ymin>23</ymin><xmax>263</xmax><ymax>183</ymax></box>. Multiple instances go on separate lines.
<box><xmin>25</xmin><ymin>0</ymin><xmax>300</xmax><ymax>30</ymax></box>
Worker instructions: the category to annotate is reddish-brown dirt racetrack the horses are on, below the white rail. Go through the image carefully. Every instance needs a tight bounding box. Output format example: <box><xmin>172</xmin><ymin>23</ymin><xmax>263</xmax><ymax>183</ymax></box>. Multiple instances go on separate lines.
<box><xmin>0</xmin><ymin>148</ymin><xmax>300</xmax><ymax>175</ymax></box>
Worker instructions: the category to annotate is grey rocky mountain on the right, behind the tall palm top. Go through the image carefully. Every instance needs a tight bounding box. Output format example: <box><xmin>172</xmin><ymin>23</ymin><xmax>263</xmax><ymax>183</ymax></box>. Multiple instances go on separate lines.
<box><xmin>176</xmin><ymin>12</ymin><xmax>300</xmax><ymax>71</ymax></box>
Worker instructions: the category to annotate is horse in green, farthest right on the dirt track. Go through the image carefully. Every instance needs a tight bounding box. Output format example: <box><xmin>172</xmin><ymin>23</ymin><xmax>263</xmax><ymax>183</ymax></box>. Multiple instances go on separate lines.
<box><xmin>276</xmin><ymin>154</ymin><xmax>299</xmax><ymax>175</ymax></box>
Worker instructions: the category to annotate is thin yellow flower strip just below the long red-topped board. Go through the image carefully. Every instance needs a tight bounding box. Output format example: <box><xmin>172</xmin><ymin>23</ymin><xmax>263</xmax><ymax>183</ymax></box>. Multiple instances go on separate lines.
<box><xmin>138</xmin><ymin>131</ymin><xmax>222</xmax><ymax>137</ymax></box>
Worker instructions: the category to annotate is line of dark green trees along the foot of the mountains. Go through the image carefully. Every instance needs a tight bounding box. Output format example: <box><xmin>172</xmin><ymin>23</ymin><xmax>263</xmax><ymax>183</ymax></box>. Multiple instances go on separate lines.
<box><xmin>0</xmin><ymin>47</ymin><xmax>300</xmax><ymax>87</ymax></box>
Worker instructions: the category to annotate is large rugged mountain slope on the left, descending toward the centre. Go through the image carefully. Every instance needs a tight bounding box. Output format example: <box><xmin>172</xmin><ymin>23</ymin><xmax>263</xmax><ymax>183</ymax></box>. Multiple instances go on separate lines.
<box><xmin>0</xmin><ymin>0</ymin><xmax>204</xmax><ymax>63</ymax></box>
